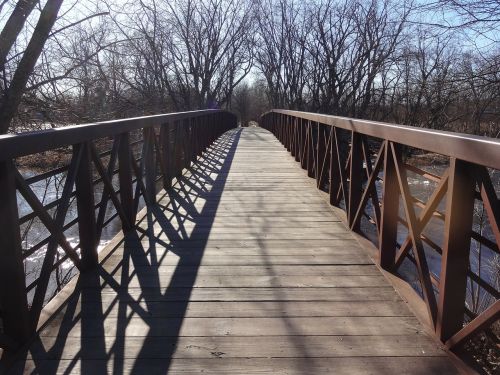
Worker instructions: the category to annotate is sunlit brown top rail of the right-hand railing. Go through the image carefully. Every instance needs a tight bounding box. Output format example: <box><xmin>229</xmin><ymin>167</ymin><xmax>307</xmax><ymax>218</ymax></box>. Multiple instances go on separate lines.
<box><xmin>268</xmin><ymin>109</ymin><xmax>500</xmax><ymax>169</ymax></box>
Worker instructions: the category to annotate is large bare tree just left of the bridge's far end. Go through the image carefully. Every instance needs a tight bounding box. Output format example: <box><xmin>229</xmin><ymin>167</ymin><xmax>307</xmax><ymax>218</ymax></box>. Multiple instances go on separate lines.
<box><xmin>168</xmin><ymin>0</ymin><xmax>253</xmax><ymax>108</ymax></box>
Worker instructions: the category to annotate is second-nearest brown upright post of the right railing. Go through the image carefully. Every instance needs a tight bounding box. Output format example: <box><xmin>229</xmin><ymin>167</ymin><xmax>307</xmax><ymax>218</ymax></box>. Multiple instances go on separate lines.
<box><xmin>379</xmin><ymin>141</ymin><xmax>401</xmax><ymax>270</ymax></box>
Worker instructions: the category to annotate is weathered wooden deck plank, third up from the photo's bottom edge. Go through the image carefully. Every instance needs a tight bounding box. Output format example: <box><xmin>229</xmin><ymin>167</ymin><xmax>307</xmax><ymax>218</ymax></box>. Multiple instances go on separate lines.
<box><xmin>39</xmin><ymin>315</ymin><xmax>423</xmax><ymax>337</ymax></box>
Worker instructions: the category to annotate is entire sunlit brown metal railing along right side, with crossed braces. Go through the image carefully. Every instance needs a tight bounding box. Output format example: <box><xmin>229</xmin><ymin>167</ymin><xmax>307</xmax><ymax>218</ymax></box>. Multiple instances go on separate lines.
<box><xmin>260</xmin><ymin>109</ymin><xmax>500</xmax><ymax>358</ymax></box>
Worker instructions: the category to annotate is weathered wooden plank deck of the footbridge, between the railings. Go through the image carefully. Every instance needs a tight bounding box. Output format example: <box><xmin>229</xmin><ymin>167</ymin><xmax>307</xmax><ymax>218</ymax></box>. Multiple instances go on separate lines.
<box><xmin>6</xmin><ymin>128</ymin><xmax>457</xmax><ymax>374</ymax></box>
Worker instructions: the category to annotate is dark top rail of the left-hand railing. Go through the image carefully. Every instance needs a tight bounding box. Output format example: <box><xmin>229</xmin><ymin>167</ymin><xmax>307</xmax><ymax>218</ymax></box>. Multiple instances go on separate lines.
<box><xmin>0</xmin><ymin>109</ymin><xmax>225</xmax><ymax>160</ymax></box>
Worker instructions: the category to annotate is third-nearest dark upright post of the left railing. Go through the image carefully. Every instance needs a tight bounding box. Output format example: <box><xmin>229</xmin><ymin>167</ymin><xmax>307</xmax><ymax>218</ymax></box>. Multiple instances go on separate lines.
<box><xmin>118</xmin><ymin>133</ymin><xmax>135</xmax><ymax>231</ymax></box>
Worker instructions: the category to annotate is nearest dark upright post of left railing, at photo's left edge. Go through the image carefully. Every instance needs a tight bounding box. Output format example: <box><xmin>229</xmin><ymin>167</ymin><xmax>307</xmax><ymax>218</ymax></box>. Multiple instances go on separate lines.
<box><xmin>0</xmin><ymin>160</ymin><xmax>30</xmax><ymax>344</ymax></box>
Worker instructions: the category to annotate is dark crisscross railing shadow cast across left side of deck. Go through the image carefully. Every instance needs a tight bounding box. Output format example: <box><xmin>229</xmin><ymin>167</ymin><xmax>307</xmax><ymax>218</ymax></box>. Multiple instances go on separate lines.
<box><xmin>6</xmin><ymin>130</ymin><xmax>241</xmax><ymax>374</ymax></box>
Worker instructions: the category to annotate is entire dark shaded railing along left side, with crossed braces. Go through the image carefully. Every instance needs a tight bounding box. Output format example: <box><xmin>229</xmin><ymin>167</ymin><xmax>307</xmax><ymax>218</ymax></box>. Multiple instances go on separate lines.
<box><xmin>0</xmin><ymin>110</ymin><xmax>236</xmax><ymax>350</ymax></box>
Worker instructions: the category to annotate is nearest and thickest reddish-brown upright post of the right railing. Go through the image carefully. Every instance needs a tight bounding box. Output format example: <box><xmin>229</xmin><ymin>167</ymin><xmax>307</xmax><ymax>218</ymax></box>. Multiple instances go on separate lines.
<box><xmin>436</xmin><ymin>158</ymin><xmax>476</xmax><ymax>341</ymax></box>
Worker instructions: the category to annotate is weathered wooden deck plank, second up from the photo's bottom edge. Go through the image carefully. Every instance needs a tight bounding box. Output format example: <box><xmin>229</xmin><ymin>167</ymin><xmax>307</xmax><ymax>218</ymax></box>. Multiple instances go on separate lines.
<box><xmin>30</xmin><ymin>336</ymin><xmax>444</xmax><ymax>359</ymax></box>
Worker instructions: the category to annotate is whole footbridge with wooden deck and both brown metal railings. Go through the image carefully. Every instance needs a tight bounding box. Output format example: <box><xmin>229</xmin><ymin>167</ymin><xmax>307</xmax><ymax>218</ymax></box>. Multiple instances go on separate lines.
<box><xmin>0</xmin><ymin>111</ymin><xmax>500</xmax><ymax>374</ymax></box>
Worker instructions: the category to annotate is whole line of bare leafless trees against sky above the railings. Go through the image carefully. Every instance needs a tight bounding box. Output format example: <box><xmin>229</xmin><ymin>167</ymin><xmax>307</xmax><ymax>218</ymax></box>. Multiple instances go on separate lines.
<box><xmin>0</xmin><ymin>0</ymin><xmax>500</xmax><ymax>137</ymax></box>
